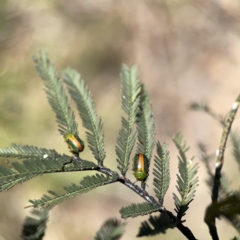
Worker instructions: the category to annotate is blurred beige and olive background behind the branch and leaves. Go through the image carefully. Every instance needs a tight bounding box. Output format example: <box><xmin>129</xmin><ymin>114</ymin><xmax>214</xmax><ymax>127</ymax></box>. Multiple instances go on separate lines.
<box><xmin>0</xmin><ymin>0</ymin><xmax>240</xmax><ymax>240</ymax></box>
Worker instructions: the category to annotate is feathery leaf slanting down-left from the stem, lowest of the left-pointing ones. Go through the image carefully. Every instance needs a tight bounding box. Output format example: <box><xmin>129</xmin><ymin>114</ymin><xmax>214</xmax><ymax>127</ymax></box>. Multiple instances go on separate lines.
<box><xmin>28</xmin><ymin>174</ymin><xmax>117</xmax><ymax>209</ymax></box>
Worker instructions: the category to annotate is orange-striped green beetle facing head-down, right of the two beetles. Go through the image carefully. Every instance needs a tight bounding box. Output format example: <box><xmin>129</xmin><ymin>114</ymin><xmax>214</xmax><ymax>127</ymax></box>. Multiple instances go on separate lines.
<box><xmin>132</xmin><ymin>153</ymin><xmax>148</xmax><ymax>182</ymax></box>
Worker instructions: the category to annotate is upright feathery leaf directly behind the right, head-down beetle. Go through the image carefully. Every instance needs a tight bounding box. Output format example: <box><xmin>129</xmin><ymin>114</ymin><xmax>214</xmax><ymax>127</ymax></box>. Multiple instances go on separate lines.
<box><xmin>137</xmin><ymin>85</ymin><xmax>155</xmax><ymax>169</ymax></box>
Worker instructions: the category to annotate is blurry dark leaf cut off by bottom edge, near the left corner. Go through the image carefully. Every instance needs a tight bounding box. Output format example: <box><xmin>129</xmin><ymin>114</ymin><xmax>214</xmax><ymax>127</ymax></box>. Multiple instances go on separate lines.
<box><xmin>21</xmin><ymin>209</ymin><xmax>48</xmax><ymax>240</ymax></box>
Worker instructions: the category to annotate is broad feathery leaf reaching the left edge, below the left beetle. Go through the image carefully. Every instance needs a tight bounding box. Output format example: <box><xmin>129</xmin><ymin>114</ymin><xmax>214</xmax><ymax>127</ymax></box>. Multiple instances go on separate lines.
<box><xmin>0</xmin><ymin>155</ymin><xmax>98</xmax><ymax>192</ymax></box>
